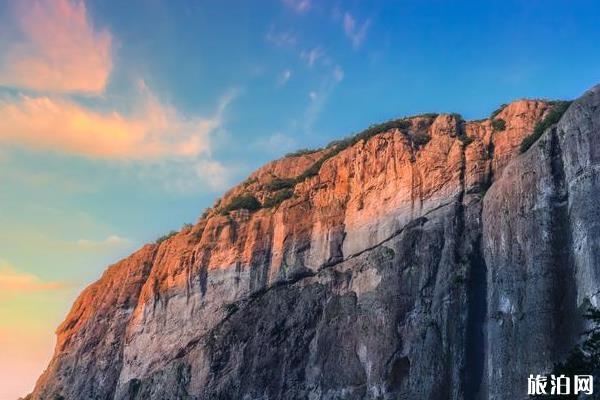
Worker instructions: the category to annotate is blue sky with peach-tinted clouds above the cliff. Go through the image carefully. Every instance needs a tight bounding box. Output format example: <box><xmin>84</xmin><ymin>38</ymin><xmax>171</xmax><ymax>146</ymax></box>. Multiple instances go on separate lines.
<box><xmin>0</xmin><ymin>0</ymin><xmax>600</xmax><ymax>400</ymax></box>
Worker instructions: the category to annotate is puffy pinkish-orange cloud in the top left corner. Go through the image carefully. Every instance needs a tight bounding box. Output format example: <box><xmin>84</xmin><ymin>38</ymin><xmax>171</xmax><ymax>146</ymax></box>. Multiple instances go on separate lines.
<box><xmin>0</xmin><ymin>0</ymin><xmax>112</xmax><ymax>93</ymax></box>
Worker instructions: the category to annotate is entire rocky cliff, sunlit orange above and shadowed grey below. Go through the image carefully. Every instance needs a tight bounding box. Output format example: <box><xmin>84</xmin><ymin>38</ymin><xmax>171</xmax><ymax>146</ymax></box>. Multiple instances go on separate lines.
<box><xmin>30</xmin><ymin>88</ymin><xmax>600</xmax><ymax>400</ymax></box>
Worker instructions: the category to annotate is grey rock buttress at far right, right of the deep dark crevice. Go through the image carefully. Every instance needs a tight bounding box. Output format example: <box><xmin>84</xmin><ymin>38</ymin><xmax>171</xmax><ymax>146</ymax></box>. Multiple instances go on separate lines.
<box><xmin>483</xmin><ymin>86</ymin><xmax>600</xmax><ymax>399</ymax></box>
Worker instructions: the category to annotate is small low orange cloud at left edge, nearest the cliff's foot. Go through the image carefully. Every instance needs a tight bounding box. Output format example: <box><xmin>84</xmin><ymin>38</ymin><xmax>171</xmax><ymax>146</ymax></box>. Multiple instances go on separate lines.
<box><xmin>0</xmin><ymin>259</ymin><xmax>72</xmax><ymax>295</ymax></box>
